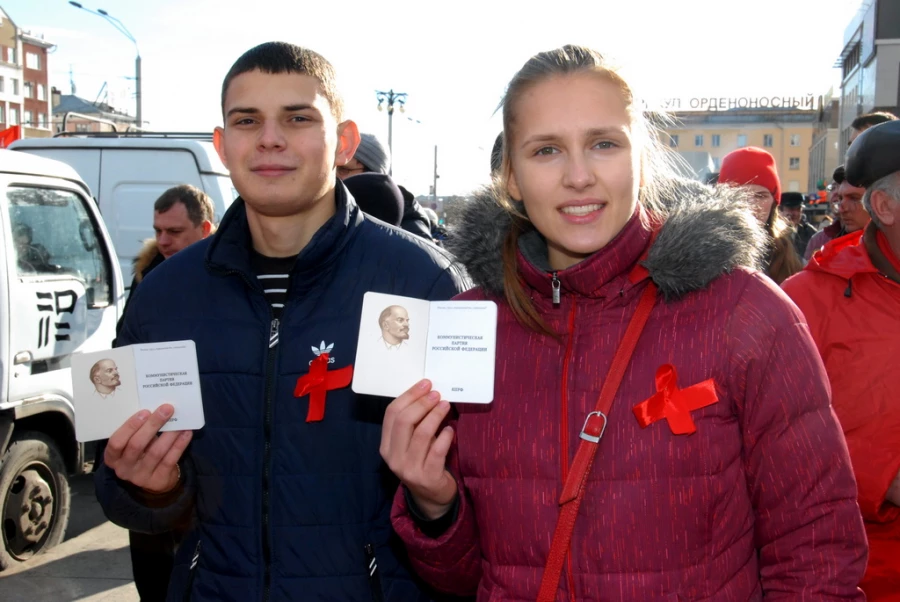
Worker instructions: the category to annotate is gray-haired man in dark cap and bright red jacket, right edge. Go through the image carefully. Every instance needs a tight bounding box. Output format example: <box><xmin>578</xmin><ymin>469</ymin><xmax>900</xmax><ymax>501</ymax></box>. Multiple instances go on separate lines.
<box><xmin>783</xmin><ymin>121</ymin><xmax>900</xmax><ymax>601</ymax></box>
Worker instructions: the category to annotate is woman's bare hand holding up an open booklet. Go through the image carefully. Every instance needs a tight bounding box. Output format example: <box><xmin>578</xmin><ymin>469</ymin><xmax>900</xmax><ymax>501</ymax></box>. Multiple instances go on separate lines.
<box><xmin>381</xmin><ymin>380</ymin><xmax>458</xmax><ymax>519</ymax></box>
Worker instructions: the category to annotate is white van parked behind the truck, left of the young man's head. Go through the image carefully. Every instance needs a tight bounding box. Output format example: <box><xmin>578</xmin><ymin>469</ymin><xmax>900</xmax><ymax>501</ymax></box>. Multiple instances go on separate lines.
<box><xmin>10</xmin><ymin>131</ymin><xmax>237</xmax><ymax>286</ymax></box>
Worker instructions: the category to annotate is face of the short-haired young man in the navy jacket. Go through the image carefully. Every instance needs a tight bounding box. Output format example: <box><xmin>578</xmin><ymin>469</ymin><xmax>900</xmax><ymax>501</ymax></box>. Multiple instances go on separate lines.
<box><xmin>216</xmin><ymin>71</ymin><xmax>359</xmax><ymax>217</ymax></box>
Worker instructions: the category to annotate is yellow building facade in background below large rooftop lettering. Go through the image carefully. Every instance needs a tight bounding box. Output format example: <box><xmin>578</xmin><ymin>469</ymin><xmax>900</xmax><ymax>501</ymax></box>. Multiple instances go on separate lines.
<box><xmin>664</xmin><ymin>104</ymin><xmax>818</xmax><ymax>194</ymax></box>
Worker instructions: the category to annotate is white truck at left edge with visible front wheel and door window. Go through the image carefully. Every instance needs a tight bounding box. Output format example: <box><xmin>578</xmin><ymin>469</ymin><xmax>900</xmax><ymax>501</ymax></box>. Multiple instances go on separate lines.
<box><xmin>0</xmin><ymin>150</ymin><xmax>124</xmax><ymax>570</ymax></box>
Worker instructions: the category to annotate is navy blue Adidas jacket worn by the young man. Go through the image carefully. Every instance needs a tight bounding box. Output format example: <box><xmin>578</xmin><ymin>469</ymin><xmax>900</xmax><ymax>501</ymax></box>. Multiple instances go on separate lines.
<box><xmin>96</xmin><ymin>183</ymin><xmax>468</xmax><ymax>602</ymax></box>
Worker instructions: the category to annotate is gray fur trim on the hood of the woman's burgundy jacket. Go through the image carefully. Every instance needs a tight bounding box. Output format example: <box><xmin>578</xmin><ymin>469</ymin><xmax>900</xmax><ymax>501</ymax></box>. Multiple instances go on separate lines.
<box><xmin>446</xmin><ymin>179</ymin><xmax>767</xmax><ymax>299</ymax></box>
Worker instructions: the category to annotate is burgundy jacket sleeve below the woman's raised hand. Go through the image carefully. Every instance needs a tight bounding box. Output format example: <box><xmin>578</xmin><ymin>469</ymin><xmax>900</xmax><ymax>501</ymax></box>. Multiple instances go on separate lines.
<box><xmin>391</xmin><ymin>423</ymin><xmax>482</xmax><ymax>596</ymax></box>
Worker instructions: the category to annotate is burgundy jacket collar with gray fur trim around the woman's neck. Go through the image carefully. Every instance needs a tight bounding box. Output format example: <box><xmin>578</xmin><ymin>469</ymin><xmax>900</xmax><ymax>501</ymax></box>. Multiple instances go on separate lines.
<box><xmin>445</xmin><ymin>179</ymin><xmax>768</xmax><ymax>299</ymax></box>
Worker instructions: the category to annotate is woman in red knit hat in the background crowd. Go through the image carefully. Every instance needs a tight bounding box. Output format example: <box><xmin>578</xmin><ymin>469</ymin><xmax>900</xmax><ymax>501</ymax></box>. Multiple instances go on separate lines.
<box><xmin>719</xmin><ymin>146</ymin><xmax>803</xmax><ymax>284</ymax></box>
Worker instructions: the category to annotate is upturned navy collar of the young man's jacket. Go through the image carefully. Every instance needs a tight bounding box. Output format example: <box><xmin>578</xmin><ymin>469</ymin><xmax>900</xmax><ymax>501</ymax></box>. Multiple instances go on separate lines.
<box><xmin>206</xmin><ymin>180</ymin><xmax>363</xmax><ymax>287</ymax></box>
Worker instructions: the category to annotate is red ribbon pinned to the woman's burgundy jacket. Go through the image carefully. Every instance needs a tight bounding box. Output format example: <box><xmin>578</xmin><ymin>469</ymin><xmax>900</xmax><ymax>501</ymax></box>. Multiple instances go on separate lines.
<box><xmin>633</xmin><ymin>364</ymin><xmax>719</xmax><ymax>435</ymax></box>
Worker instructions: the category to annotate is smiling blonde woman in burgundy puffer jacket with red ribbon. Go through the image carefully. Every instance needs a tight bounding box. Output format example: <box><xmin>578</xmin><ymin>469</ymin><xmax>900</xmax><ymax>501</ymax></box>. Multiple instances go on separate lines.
<box><xmin>381</xmin><ymin>46</ymin><xmax>867</xmax><ymax>602</ymax></box>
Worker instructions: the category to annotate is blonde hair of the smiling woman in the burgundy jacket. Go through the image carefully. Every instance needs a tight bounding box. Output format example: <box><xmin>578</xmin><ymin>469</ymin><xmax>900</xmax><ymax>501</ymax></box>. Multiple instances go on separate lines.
<box><xmin>494</xmin><ymin>45</ymin><xmax>675</xmax><ymax>336</ymax></box>
